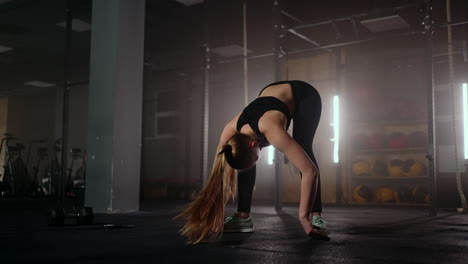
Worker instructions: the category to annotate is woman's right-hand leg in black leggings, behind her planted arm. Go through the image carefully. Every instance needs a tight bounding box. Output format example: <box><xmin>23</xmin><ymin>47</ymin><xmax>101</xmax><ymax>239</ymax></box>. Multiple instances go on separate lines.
<box><xmin>293</xmin><ymin>87</ymin><xmax>322</xmax><ymax>213</ymax></box>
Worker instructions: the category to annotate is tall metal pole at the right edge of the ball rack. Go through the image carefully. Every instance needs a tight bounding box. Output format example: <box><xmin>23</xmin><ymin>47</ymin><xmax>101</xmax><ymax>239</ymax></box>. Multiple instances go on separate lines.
<box><xmin>423</xmin><ymin>0</ymin><xmax>437</xmax><ymax>216</ymax></box>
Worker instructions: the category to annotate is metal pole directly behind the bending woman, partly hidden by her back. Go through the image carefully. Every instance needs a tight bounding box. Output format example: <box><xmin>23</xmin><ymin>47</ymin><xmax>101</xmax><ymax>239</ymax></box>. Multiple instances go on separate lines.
<box><xmin>273</xmin><ymin>0</ymin><xmax>282</xmax><ymax>211</ymax></box>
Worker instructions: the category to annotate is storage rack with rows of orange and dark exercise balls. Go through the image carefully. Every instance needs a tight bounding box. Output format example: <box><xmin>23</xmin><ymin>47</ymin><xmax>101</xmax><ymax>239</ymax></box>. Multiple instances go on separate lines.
<box><xmin>349</xmin><ymin>119</ymin><xmax>430</xmax><ymax>206</ymax></box>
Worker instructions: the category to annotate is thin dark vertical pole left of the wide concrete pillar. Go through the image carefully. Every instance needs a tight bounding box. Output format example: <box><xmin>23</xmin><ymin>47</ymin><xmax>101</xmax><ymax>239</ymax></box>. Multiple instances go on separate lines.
<box><xmin>59</xmin><ymin>0</ymin><xmax>73</xmax><ymax>206</ymax></box>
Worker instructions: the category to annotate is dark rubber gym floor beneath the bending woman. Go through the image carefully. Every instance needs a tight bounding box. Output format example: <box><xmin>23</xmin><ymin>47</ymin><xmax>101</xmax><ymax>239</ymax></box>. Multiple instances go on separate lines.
<box><xmin>0</xmin><ymin>201</ymin><xmax>468</xmax><ymax>264</ymax></box>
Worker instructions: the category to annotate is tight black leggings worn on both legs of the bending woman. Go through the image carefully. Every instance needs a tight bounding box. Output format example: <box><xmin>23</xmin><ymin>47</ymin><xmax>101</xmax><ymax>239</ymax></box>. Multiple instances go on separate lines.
<box><xmin>237</xmin><ymin>81</ymin><xmax>322</xmax><ymax>213</ymax></box>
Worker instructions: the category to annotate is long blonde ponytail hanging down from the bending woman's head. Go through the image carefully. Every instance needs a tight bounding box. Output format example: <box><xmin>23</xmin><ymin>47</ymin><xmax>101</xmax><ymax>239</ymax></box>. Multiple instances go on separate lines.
<box><xmin>176</xmin><ymin>145</ymin><xmax>237</xmax><ymax>244</ymax></box>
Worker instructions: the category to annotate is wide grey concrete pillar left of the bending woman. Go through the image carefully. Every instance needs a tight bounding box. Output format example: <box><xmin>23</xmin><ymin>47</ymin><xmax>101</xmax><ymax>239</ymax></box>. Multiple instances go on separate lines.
<box><xmin>85</xmin><ymin>0</ymin><xmax>145</xmax><ymax>212</ymax></box>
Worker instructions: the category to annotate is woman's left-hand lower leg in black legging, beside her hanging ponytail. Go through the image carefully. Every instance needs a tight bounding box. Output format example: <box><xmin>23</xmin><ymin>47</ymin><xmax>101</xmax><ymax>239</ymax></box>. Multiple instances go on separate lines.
<box><xmin>237</xmin><ymin>166</ymin><xmax>256</xmax><ymax>214</ymax></box>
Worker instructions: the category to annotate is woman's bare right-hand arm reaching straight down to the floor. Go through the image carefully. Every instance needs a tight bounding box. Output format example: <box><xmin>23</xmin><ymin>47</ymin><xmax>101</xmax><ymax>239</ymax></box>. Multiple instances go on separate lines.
<box><xmin>264</xmin><ymin>125</ymin><xmax>318</xmax><ymax>235</ymax></box>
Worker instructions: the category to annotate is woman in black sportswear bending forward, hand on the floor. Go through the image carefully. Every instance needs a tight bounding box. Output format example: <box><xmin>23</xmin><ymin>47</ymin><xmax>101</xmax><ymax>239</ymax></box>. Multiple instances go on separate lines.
<box><xmin>177</xmin><ymin>81</ymin><xmax>328</xmax><ymax>244</ymax></box>
